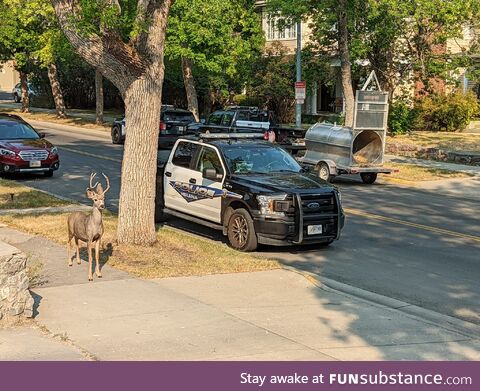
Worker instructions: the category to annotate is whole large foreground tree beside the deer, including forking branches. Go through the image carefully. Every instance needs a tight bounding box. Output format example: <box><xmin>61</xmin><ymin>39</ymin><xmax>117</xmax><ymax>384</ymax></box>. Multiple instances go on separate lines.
<box><xmin>52</xmin><ymin>0</ymin><xmax>173</xmax><ymax>245</ymax></box>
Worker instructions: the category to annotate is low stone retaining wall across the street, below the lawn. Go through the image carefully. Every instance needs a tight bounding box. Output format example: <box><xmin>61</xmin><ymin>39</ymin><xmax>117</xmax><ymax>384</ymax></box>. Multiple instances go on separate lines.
<box><xmin>385</xmin><ymin>143</ymin><xmax>480</xmax><ymax>166</ymax></box>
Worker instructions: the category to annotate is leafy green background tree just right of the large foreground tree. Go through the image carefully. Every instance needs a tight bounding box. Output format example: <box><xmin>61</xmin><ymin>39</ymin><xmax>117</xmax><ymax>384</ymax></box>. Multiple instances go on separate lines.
<box><xmin>166</xmin><ymin>0</ymin><xmax>264</xmax><ymax>119</ymax></box>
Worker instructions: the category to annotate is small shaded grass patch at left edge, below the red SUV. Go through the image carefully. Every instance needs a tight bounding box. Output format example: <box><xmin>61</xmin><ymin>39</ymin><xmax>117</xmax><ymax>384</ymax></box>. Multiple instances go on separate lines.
<box><xmin>0</xmin><ymin>179</ymin><xmax>69</xmax><ymax>209</ymax></box>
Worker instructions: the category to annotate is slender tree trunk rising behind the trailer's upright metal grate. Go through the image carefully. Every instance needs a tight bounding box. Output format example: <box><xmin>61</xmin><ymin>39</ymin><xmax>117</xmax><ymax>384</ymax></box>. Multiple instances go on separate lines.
<box><xmin>338</xmin><ymin>0</ymin><xmax>355</xmax><ymax>126</ymax></box>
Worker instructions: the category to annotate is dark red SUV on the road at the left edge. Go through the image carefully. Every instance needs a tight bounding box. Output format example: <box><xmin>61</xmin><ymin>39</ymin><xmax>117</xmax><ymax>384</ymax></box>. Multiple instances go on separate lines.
<box><xmin>0</xmin><ymin>113</ymin><xmax>60</xmax><ymax>177</ymax></box>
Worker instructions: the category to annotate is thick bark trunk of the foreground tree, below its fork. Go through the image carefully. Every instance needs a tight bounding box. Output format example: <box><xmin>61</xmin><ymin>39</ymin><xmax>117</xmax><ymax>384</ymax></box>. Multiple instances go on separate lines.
<box><xmin>117</xmin><ymin>77</ymin><xmax>163</xmax><ymax>245</ymax></box>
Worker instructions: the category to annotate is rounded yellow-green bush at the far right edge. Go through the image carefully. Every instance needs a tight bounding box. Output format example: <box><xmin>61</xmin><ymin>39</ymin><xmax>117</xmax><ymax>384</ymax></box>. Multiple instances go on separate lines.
<box><xmin>415</xmin><ymin>92</ymin><xmax>480</xmax><ymax>132</ymax></box>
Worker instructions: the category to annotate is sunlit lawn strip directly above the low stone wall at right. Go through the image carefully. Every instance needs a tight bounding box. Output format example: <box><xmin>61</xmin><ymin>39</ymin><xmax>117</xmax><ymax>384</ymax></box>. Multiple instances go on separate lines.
<box><xmin>387</xmin><ymin>132</ymin><xmax>480</xmax><ymax>153</ymax></box>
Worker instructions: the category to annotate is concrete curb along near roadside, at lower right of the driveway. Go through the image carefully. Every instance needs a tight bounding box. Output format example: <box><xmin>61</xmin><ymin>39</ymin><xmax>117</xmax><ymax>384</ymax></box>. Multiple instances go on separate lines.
<box><xmin>282</xmin><ymin>266</ymin><xmax>480</xmax><ymax>338</ymax></box>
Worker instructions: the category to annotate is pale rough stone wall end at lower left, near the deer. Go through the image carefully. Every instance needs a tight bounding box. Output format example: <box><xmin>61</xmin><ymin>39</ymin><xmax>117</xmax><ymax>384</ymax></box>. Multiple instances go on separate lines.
<box><xmin>0</xmin><ymin>242</ymin><xmax>34</xmax><ymax>321</ymax></box>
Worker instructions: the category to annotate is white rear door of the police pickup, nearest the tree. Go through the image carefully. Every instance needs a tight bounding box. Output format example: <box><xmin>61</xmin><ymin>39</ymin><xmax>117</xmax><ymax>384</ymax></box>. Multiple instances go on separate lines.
<box><xmin>163</xmin><ymin>141</ymin><xmax>200</xmax><ymax>213</ymax></box>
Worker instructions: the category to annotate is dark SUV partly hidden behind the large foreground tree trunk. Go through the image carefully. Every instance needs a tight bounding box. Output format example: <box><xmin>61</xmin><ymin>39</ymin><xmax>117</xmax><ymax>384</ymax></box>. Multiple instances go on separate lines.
<box><xmin>112</xmin><ymin>105</ymin><xmax>195</xmax><ymax>149</ymax></box>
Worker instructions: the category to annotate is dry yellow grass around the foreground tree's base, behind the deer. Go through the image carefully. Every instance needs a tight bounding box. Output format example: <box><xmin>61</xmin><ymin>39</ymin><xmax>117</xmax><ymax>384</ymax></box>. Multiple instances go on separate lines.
<box><xmin>0</xmin><ymin>213</ymin><xmax>279</xmax><ymax>278</ymax></box>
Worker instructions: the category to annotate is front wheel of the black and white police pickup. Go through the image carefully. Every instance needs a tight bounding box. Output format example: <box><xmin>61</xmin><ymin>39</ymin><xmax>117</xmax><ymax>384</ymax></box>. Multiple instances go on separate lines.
<box><xmin>227</xmin><ymin>208</ymin><xmax>258</xmax><ymax>251</ymax></box>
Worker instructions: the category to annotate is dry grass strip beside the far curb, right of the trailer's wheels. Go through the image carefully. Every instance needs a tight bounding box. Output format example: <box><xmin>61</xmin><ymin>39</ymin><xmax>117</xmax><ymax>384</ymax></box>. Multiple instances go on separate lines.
<box><xmin>382</xmin><ymin>162</ymin><xmax>472</xmax><ymax>182</ymax></box>
